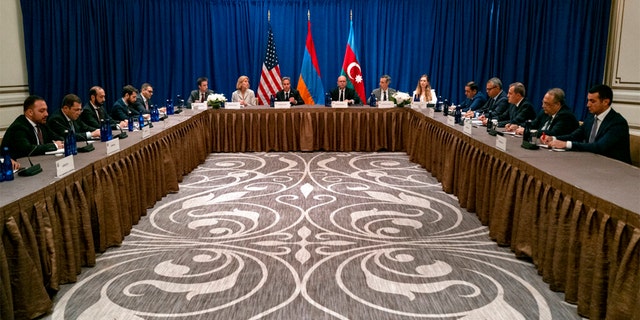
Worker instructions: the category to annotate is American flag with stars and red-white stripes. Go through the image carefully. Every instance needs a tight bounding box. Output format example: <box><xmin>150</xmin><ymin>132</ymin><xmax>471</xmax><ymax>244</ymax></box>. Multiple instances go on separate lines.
<box><xmin>258</xmin><ymin>24</ymin><xmax>282</xmax><ymax>105</ymax></box>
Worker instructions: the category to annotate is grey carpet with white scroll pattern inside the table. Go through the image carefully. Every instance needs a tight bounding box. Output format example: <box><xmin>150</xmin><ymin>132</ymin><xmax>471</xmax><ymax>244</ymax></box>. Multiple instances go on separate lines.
<box><xmin>46</xmin><ymin>153</ymin><xmax>580</xmax><ymax>320</ymax></box>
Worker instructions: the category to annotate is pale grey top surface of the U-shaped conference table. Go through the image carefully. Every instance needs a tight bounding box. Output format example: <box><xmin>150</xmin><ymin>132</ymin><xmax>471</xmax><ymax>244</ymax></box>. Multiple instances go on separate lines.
<box><xmin>0</xmin><ymin>105</ymin><xmax>640</xmax><ymax>212</ymax></box>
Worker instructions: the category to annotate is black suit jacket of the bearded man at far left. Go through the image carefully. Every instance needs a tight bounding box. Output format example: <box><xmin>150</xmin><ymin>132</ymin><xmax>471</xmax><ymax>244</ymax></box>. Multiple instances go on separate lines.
<box><xmin>1</xmin><ymin>115</ymin><xmax>63</xmax><ymax>160</ymax></box>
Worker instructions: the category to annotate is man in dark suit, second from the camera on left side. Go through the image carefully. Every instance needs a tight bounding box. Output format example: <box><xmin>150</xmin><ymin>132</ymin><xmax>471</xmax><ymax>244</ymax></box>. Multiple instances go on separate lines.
<box><xmin>47</xmin><ymin>93</ymin><xmax>100</xmax><ymax>141</ymax></box>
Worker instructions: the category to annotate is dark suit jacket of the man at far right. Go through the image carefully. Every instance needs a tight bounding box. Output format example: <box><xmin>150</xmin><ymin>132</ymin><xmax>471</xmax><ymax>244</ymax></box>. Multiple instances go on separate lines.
<box><xmin>556</xmin><ymin>109</ymin><xmax>631</xmax><ymax>164</ymax></box>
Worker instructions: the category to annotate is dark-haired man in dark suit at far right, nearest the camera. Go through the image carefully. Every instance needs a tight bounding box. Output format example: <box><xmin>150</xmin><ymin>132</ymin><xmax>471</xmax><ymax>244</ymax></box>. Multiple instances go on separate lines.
<box><xmin>546</xmin><ymin>84</ymin><xmax>631</xmax><ymax>164</ymax></box>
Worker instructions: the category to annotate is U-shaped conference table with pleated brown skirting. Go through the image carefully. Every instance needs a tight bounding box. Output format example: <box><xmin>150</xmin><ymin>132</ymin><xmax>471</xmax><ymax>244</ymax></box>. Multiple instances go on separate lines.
<box><xmin>0</xmin><ymin>106</ymin><xmax>640</xmax><ymax>319</ymax></box>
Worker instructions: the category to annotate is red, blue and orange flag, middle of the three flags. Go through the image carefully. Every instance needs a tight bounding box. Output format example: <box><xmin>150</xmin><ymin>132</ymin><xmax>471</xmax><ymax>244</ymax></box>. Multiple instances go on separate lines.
<box><xmin>297</xmin><ymin>21</ymin><xmax>324</xmax><ymax>104</ymax></box>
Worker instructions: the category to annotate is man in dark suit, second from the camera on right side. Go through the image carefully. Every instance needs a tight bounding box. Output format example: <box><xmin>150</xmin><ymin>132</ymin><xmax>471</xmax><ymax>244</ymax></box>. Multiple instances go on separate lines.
<box><xmin>516</xmin><ymin>88</ymin><xmax>579</xmax><ymax>137</ymax></box>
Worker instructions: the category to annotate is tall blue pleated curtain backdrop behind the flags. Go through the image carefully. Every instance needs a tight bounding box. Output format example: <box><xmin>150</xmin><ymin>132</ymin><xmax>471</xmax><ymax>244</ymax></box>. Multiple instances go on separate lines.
<box><xmin>21</xmin><ymin>0</ymin><xmax>611</xmax><ymax>118</ymax></box>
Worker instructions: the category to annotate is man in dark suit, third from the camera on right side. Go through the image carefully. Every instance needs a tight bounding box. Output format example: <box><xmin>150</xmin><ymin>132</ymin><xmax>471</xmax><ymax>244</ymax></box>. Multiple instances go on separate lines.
<box><xmin>498</xmin><ymin>82</ymin><xmax>536</xmax><ymax>132</ymax></box>
